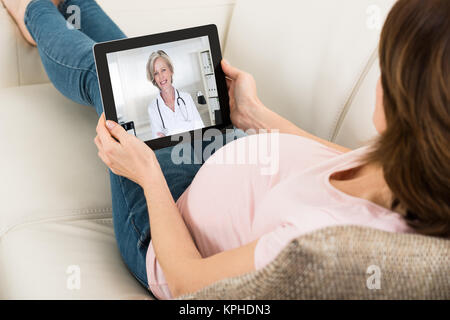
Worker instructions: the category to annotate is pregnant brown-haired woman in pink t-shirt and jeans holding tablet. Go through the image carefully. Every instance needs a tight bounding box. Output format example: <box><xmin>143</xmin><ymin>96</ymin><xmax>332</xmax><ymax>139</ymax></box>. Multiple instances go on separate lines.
<box><xmin>5</xmin><ymin>0</ymin><xmax>450</xmax><ymax>299</ymax></box>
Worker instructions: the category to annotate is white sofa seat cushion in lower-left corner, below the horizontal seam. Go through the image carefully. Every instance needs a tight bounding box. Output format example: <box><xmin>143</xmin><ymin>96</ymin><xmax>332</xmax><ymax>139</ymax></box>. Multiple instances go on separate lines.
<box><xmin>0</xmin><ymin>219</ymin><xmax>153</xmax><ymax>299</ymax></box>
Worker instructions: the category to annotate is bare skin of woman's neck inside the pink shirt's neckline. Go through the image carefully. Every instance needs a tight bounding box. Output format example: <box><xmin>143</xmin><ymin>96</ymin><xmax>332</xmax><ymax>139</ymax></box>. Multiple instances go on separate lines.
<box><xmin>330</xmin><ymin>164</ymin><xmax>404</xmax><ymax>214</ymax></box>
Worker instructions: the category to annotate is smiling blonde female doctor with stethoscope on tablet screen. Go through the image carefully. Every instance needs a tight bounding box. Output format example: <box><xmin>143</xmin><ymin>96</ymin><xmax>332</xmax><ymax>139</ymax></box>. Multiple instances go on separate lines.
<box><xmin>147</xmin><ymin>50</ymin><xmax>204</xmax><ymax>139</ymax></box>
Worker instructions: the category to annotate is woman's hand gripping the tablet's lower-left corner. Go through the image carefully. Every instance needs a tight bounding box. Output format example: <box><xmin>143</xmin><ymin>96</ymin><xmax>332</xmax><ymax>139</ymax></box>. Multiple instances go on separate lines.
<box><xmin>94</xmin><ymin>113</ymin><xmax>161</xmax><ymax>187</ymax></box>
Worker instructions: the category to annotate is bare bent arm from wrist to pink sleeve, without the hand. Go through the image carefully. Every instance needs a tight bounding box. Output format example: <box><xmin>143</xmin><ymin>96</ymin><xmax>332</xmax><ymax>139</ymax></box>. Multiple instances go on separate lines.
<box><xmin>143</xmin><ymin>172</ymin><xmax>256</xmax><ymax>297</ymax></box>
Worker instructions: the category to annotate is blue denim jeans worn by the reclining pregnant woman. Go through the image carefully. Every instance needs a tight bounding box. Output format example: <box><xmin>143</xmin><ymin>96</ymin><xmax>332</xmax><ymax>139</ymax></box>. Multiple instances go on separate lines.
<box><xmin>25</xmin><ymin>0</ymin><xmax>245</xmax><ymax>289</ymax></box>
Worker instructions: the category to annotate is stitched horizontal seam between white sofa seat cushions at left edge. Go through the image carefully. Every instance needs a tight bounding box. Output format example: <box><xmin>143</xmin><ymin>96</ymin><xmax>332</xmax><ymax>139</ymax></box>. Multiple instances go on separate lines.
<box><xmin>0</xmin><ymin>208</ymin><xmax>112</xmax><ymax>239</ymax></box>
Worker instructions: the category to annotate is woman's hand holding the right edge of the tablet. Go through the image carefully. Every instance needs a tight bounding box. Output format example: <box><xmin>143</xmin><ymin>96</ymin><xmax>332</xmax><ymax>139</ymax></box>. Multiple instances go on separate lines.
<box><xmin>222</xmin><ymin>60</ymin><xmax>265</xmax><ymax>130</ymax></box>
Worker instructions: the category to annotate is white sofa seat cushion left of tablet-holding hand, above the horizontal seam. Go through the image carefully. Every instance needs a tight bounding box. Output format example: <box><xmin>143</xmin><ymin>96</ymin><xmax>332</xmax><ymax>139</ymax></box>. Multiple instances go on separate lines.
<box><xmin>0</xmin><ymin>84</ymin><xmax>111</xmax><ymax>237</ymax></box>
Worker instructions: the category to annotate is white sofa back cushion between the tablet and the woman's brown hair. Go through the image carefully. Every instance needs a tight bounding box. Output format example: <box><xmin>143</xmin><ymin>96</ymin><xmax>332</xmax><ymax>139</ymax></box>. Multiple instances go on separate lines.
<box><xmin>225</xmin><ymin>0</ymin><xmax>395</xmax><ymax>148</ymax></box>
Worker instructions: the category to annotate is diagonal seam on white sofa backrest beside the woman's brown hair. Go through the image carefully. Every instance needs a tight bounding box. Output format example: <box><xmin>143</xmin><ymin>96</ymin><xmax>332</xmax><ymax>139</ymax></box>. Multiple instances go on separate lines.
<box><xmin>328</xmin><ymin>46</ymin><xmax>378</xmax><ymax>142</ymax></box>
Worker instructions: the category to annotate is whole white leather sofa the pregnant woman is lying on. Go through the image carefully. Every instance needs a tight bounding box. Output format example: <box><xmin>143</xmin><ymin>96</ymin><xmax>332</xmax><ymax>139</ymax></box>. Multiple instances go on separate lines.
<box><xmin>0</xmin><ymin>0</ymin><xmax>394</xmax><ymax>299</ymax></box>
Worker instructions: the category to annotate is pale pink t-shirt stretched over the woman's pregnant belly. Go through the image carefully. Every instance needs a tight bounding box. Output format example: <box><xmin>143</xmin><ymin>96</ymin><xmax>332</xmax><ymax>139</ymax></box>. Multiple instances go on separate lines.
<box><xmin>147</xmin><ymin>133</ymin><xmax>411</xmax><ymax>299</ymax></box>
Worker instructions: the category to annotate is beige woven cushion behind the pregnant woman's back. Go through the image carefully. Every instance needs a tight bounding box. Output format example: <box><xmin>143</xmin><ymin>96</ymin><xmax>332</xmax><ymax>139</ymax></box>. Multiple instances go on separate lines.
<box><xmin>180</xmin><ymin>226</ymin><xmax>450</xmax><ymax>300</ymax></box>
